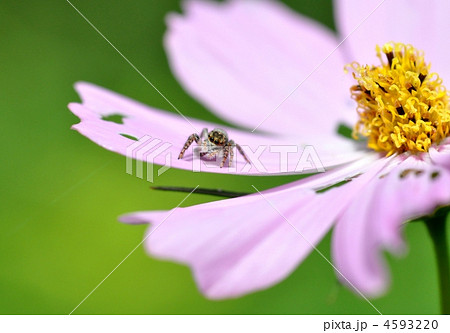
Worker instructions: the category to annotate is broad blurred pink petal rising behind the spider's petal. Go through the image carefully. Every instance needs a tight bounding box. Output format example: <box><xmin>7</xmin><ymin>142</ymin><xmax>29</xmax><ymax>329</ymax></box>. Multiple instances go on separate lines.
<box><xmin>165</xmin><ymin>0</ymin><xmax>356</xmax><ymax>140</ymax></box>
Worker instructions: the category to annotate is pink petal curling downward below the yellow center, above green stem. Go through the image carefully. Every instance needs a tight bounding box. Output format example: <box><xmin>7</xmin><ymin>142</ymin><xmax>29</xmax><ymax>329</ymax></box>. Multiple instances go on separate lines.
<box><xmin>333</xmin><ymin>157</ymin><xmax>450</xmax><ymax>297</ymax></box>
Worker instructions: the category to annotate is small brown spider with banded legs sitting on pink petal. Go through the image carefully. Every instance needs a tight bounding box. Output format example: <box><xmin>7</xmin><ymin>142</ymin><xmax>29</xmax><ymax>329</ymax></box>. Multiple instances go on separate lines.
<box><xmin>178</xmin><ymin>128</ymin><xmax>250</xmax><ymax>168</ymax></box>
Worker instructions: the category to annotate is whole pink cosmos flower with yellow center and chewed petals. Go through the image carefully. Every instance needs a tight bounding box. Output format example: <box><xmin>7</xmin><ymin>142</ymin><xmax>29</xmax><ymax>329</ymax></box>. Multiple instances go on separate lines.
<box><xmin>69</xmin><ymin>0</ymin><xmax>450</xmax><ymax>299</ymax></box>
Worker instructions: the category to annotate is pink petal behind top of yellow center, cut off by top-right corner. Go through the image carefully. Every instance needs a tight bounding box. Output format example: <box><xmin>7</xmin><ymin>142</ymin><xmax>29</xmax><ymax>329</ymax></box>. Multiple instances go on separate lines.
<box><xmin>335</xmin><ymin>0</ymin><xmax>450</xmax><ymax>79</ymax></box>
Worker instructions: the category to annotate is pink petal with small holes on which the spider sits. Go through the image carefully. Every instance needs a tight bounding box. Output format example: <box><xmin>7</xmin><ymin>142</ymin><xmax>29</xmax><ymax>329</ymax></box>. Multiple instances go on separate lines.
<box><xmin>69</xmin><ymin>83</ymin><xmax>367</xmax><ymax>175</ymax></box>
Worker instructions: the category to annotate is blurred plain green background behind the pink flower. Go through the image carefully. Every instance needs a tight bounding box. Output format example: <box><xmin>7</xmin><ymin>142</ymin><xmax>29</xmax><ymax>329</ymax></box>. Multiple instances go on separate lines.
<box><xmin>0</xmin><ymin>0</ymin><xmax>438</xmax><ymax>314</ymax></box>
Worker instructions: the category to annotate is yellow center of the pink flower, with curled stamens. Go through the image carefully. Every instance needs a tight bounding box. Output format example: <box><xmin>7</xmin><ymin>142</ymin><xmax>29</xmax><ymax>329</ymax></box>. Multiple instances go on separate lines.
<box><xmin>346</xmin><ymin>43</ymin><xmax>450</xmax><ymax>156</ymax></box>
